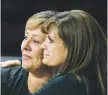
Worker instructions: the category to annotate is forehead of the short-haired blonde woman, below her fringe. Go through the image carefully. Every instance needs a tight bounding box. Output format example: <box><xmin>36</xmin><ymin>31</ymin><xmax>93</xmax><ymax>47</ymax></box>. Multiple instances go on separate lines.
<box><xmin>25</xmin><ymin>28</ymin><xmax>46</xmax><ymax>39</ymax></box>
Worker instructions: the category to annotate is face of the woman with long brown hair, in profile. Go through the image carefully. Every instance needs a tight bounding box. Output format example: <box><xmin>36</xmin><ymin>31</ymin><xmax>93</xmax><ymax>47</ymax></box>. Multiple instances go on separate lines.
<box><xmin>41</xmin><ymin>27</ymin><xmax>68</xmax><ymax>67</ymax></box>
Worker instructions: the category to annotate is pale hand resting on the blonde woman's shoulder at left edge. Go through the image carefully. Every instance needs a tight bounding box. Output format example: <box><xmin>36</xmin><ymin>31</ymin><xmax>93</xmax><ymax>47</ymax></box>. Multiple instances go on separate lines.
<box><xmin>0</xmin><ymin>60</ymin><xmax>21</xmax><ymax>68</ymax></box>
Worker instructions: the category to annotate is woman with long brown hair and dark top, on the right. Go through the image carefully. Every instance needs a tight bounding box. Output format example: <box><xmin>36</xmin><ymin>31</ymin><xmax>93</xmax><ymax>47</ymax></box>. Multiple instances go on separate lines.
<box><xmin>36</xmin><ymin>10</ymin><xmax>107</xmax><ymax>95</ymax></box>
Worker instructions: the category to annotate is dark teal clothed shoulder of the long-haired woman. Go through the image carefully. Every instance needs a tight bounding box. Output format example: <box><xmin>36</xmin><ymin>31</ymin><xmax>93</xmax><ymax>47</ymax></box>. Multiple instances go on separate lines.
<box><xmin>37</xmin><ymin>73</ymin><xmax>86</xmax><ymax>95</ymax></box>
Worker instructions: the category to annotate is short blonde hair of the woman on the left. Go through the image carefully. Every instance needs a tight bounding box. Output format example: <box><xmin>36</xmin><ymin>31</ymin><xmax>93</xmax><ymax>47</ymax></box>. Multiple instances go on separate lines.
<box><xmin>25</xmin><ymin>11</ymin><xmax>58</xmax><ymax>30</ymax></box>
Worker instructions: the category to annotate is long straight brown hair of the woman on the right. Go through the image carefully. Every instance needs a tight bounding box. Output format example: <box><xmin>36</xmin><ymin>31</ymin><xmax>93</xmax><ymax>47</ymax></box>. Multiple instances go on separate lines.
<box><xmin>44</xmin><ymin>10</ymin><xmax>107</xmax><ymax>95</ymax></box>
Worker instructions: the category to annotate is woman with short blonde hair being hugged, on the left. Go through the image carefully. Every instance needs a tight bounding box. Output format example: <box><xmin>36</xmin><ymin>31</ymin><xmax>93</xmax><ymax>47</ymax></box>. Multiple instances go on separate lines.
<box><xmin>1</xmin><ymin>11</ymin><xmax>60</xmax><ymax>95</ymax></box>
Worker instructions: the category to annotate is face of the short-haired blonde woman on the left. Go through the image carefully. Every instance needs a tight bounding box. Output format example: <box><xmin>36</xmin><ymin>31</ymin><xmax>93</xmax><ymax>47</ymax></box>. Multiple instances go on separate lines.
<box><xmin>21</xmin><ymin>28</ymin><xmax>46</xmax><ymax>71</ymax></box>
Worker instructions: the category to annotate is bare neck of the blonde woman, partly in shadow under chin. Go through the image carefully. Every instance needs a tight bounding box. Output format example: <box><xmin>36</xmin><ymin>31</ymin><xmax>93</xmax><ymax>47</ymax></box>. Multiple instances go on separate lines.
<box><xmin>28</xmin><ymin>67</ymin><xmax>57</xmax><ymax>93</ymax></box>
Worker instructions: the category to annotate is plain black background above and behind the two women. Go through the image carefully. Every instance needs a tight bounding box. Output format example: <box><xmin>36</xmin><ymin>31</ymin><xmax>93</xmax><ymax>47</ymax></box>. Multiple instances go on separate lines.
<box><xmin>1</xmin><ymin>0</ymin><xmax>107</xmax><ymax>56</ymax></box>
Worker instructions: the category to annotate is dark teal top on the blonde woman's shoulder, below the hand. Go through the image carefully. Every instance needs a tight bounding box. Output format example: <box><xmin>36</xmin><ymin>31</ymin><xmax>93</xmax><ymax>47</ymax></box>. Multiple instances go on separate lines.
<box><xmin>1</xmin><ymin>66</ymin><xmax>29</xmax><ymax>95</ymax></box>
